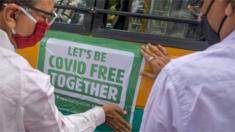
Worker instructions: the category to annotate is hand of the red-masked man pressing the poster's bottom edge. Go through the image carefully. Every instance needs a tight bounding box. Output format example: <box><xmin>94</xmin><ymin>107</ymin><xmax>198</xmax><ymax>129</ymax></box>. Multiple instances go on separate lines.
<box><xmin>103</xmin><ymin>104</ymin><xmax>131</xmax><ymax>132</ymax></box>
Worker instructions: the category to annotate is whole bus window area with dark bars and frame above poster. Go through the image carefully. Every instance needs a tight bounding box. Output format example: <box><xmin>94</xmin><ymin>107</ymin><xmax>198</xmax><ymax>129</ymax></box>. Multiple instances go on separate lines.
<box><xmin>51</xmin><ymin>0</ymin><xmax>208</xmax><ymax>50</ymax></box>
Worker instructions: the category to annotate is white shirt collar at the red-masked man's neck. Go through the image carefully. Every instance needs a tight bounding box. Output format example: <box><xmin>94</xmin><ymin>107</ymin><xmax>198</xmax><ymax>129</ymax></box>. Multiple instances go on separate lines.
<box><xmin>0</xmin><ymin>29</ymin><xmax>15</xmax><ymax>52</ymax></box>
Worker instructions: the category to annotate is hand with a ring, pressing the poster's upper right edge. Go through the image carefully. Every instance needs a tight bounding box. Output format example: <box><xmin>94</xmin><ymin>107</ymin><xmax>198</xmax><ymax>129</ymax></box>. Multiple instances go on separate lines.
<box><xmin>140</xmin><ymin>44</ymin><xmax>170</xmax><ymax>79</ymax></box>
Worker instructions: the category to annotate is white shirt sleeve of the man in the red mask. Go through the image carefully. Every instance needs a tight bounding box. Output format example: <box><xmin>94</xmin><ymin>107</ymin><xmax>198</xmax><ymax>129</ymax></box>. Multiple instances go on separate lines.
<box><xmin>22</xmin><ymin>70</ymin><xmax>105</xmax><ymax>132</ymax></box>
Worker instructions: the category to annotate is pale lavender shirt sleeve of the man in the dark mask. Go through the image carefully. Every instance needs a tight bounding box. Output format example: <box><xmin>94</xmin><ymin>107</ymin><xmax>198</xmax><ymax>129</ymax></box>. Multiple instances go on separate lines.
<box><xmin>140</xmin><ymin>69</ymin><xmax>182</xmax><ymax>132</ymax></box>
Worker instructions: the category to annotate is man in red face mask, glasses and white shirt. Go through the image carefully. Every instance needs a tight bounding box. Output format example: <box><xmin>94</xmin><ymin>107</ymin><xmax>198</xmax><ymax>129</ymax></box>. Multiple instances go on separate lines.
<box><xmin>0</xmin><ymin>0</ymin><xmax>130</xmax><ymax>132</ymax></box>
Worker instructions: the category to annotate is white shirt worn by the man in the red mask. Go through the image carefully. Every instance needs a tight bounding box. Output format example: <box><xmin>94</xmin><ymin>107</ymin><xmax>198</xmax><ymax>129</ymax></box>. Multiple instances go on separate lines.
<box><xmin>0</xmin><ymin>29</ymin><xmax>105</xmax><ymax>132</ymax></box>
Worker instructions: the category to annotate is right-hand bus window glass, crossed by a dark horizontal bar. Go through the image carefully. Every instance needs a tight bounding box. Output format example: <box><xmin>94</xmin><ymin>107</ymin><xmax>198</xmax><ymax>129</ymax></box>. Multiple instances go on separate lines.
<box><xmin>106</xmin><ymin>0</ymin><xmax>201</xmax><ymax>40</ymax></box>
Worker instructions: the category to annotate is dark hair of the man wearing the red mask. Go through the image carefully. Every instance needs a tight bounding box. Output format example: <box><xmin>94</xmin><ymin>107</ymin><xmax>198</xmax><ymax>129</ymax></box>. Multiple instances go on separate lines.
<box><xmin>0</xmin><ymin>0</ymin><xmax>39</xmax><ymax>11</ymax></box>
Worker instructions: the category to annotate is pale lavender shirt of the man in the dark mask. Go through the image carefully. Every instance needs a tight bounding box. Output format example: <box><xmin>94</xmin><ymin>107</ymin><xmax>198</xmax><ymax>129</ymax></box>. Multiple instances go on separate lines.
<box><xmin>141</xmin><ymin>31</ymin><xmax>235</xmax><ymax>132</ymax></box>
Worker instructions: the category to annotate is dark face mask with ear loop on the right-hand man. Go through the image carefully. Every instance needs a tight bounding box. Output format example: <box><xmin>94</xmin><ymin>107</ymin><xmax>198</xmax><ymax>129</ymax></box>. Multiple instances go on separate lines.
<box><xmin>201</xmin><ymin>0</ymin><xmax>227</xmax><ymax>45</ymax></box>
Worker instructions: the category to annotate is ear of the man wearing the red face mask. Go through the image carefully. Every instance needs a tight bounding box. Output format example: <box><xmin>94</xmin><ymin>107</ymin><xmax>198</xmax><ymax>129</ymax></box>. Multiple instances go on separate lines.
<box><xmin>3</xmin><ymin>4</ymin><xmax>21</xmax><ymax>29</ymax></box>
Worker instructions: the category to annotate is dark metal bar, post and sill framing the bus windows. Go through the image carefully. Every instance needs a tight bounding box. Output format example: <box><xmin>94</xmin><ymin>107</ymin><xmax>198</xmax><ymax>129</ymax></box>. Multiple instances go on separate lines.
<box><xmin>53</xmin><ymin>2</ymin><xmax>208</xmax><ymax>50</ymax></box>
